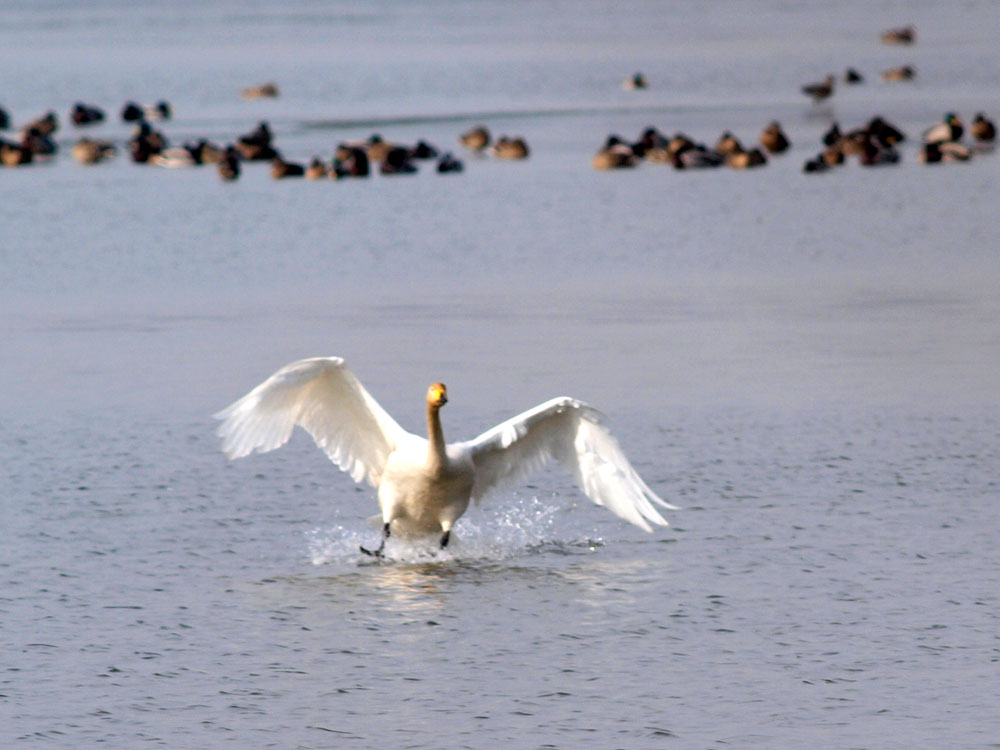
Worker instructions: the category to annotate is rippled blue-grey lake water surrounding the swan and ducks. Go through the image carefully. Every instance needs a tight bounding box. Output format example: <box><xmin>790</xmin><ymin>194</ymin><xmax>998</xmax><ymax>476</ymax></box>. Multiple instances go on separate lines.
<box><xmin>0</xmin><ymin>0</ymin><xmax>1000</xmax><ymax>750</ymax></box>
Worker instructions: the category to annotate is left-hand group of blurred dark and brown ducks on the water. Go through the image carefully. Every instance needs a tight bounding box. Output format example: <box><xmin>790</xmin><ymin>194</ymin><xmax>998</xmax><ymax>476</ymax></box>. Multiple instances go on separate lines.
<box><xmin>0</xmin><ymin>95</ymin><xmax>530</xmax><ymax>181</ymax></box>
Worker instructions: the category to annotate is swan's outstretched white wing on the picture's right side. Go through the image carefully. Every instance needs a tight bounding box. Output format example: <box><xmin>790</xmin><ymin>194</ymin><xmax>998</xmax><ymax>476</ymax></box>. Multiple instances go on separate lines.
<box><xmin>462</xmin><ymin>397</ymin><xmax>676</xmax><ymax>531</ymax></box>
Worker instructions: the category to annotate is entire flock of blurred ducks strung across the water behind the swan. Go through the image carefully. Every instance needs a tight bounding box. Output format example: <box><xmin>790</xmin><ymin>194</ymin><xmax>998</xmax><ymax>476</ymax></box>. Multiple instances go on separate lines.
<box><xmin>0</xmin><ymin>26</ymin><xmax>996</xmax><ymax>181</ymax></box>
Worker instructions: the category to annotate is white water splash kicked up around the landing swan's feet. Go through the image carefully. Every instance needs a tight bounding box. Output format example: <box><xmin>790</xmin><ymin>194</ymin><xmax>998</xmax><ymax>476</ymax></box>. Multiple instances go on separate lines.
<box><xmin>306</xmin><ymin>497</ymin><xmax>603</xmax><ymax>565</ymax></box>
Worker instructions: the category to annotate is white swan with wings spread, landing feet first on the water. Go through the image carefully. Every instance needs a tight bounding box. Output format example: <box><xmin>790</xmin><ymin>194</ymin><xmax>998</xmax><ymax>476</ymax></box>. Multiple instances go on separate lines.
<box><xmin>215</xmin><ymin>357</ymin><xmax>677</xmax><ymax>556</ymax></box>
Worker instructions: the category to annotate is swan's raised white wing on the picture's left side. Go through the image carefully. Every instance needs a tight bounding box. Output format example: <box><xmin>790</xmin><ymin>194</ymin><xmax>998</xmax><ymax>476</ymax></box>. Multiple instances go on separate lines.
<box><xmin>215</xmin><ymin>357</ymin><xmax>408</xmax><ymax>487</ymax></box>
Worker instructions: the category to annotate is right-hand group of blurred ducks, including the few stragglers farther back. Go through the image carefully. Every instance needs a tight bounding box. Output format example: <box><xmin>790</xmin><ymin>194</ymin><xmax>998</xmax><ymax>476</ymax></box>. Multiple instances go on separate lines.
<box><xmin>591</xmin><ymin>26</ymin><xmax>996</xmax><ymax>173</ymax></box>
